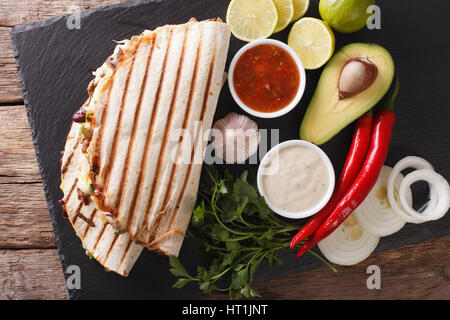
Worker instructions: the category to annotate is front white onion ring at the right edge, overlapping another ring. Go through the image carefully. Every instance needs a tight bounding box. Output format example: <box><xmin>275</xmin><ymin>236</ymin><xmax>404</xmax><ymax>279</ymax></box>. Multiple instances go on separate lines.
<box><xmin>399</xmin><ymin>169</ymin><xmax>450</xmax><ymax>222</ymax></box>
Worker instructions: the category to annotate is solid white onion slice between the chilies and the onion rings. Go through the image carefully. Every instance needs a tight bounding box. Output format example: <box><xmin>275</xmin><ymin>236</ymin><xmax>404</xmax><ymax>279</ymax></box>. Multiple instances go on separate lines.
<box><xmin>353</xmin><ymin>166</ymin><xmax>412</xmax><ymax>237</ymax></box>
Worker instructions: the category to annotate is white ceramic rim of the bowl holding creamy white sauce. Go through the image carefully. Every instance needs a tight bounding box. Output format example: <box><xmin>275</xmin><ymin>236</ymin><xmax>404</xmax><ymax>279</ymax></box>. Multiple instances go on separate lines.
<box><xmin>257</xmin><ymin>140</ymin><xmax>335</xmax><ymax>219</ymax></box>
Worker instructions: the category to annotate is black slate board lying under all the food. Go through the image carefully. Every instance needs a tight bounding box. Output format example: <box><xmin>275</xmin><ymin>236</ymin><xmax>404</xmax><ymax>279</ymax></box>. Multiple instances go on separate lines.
<box><xmin>11</xmin><ymin>0</ymin><xmax>450</xmax><ymax>299</ymax></box>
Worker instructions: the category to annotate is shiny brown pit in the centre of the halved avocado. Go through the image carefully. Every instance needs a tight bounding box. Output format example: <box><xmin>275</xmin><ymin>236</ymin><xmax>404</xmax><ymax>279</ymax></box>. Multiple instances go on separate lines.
<box><xmin>339</xmin><ymin>57</ymin><xmax>378</xmax><ymax>100</ymax></box>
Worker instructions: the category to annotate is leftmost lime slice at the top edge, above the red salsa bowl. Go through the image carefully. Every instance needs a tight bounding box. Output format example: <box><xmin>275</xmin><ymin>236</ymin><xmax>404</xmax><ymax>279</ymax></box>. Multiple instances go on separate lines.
<box><xmin>227</xmin><ymin>0</ymin><xmax>278</xmax><ymax>42</ymax></box>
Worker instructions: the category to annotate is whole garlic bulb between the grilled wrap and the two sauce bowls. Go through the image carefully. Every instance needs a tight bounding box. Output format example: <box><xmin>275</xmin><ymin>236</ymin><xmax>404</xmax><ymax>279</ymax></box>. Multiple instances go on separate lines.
<box><xmin>212</xmin><ymin>112</ymin><xmax>260</xmax><ymax>163</ymax></box>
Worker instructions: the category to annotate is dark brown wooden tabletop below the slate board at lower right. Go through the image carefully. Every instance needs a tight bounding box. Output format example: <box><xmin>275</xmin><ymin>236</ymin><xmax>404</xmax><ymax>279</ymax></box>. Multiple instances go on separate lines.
<box><xmin>207</xmin><ymin>236</ymin><xmax>450</xmax><ymax>300</ymax></box>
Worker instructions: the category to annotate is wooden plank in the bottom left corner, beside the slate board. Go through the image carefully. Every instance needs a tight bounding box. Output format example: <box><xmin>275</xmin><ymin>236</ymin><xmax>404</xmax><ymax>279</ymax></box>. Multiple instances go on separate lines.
<box><xmin>0</xmin><ymin>249</ymin><xmax>68</xmax><ymax>300</ymax></box>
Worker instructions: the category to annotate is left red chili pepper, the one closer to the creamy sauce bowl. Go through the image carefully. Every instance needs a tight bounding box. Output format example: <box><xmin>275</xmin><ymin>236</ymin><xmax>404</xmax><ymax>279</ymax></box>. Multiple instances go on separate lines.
<box><xmin>291</xmin><ymin>112</ymin><xmax>373</xmax><ymax>249</ymax></box>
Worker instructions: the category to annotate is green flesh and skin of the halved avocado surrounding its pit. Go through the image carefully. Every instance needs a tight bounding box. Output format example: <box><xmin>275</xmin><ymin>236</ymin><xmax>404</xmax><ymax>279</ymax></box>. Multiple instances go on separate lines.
<box><xmin>300</xmin><ymin>43</ymin><xmax>394</xmax><ymax>145</ymax></box>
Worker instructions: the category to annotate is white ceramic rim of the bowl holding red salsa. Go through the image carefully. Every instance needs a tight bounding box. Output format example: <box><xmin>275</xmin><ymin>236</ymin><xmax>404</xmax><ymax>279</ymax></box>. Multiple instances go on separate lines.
<box><xmin>228</xmin><ymin>39</ymin><xmax>306</xmax><ymax>118</ymax></box>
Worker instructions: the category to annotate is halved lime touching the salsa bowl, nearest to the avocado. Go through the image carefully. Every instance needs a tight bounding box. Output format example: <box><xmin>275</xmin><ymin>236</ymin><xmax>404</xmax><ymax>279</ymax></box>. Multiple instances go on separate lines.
<box><xmin>288</xmin><ymin>17</ymin><xmax>335</xmax><ymax>70</ymax></box>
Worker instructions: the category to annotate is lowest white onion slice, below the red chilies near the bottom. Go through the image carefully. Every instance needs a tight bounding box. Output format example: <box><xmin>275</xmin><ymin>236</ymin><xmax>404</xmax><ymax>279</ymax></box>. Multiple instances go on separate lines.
<box><xmin>318</xmin><ymin>214</ymin><xmax>380</xmax><ymax>266</ymax></box>
